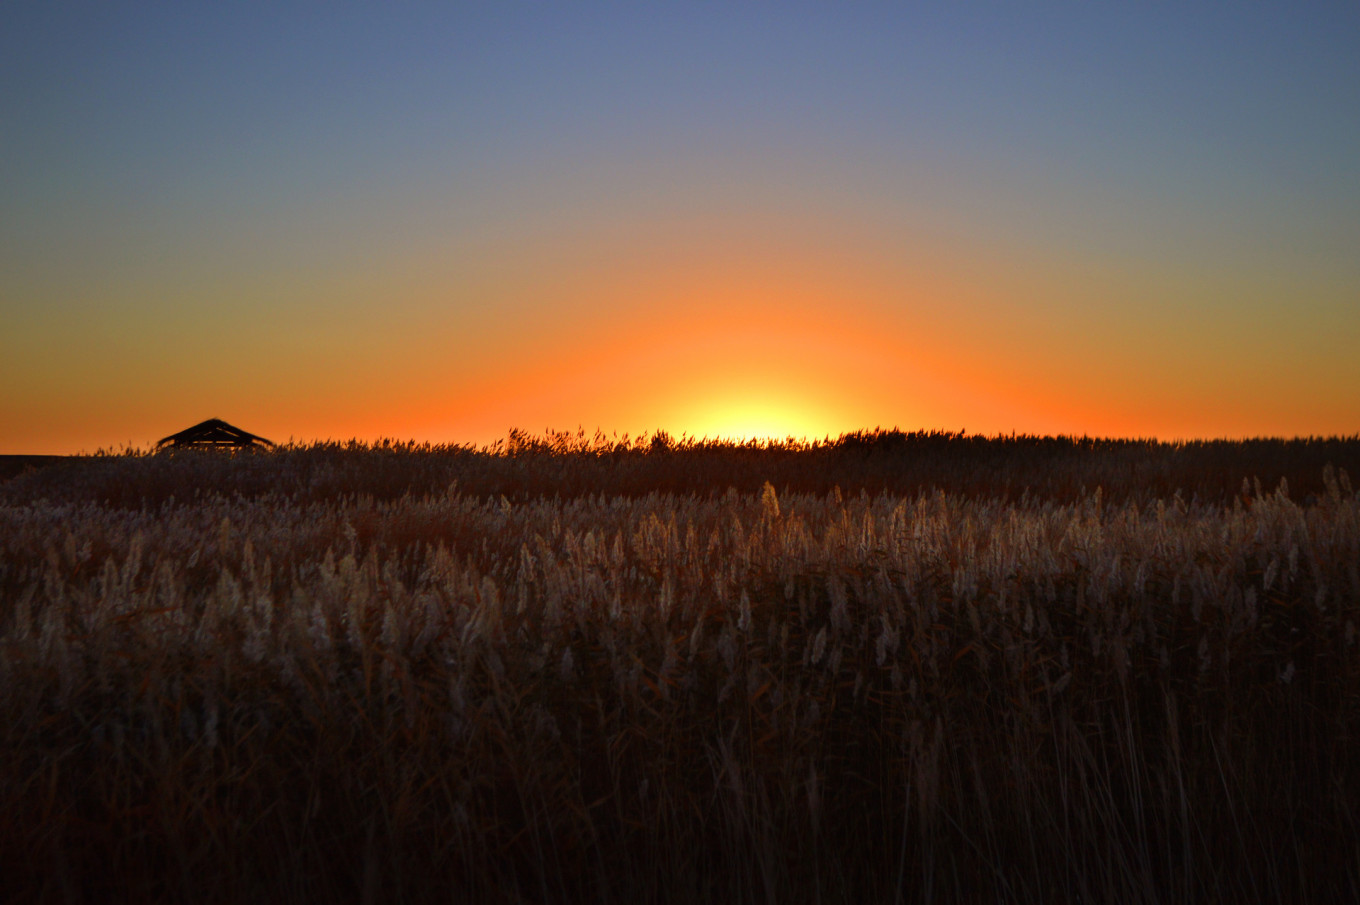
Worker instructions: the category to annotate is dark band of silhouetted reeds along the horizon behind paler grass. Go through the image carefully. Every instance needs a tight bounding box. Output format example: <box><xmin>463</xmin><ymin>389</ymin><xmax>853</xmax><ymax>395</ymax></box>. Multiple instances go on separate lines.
<box><xmin>0</xmin><ymin>430</ymin><xmax>1360</xmax><ymax>508</ymax></box>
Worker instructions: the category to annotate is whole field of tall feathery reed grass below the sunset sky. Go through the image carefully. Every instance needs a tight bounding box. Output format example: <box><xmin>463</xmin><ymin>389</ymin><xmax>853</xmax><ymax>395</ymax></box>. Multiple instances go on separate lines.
<box><xmin>0</xmin><ymin>431</ymin><xmax>1360</xmax><ymax>904</ymax></box>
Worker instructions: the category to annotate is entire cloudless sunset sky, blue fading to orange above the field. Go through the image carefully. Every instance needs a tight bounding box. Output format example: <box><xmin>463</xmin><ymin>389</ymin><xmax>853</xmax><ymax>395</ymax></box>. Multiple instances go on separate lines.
<box><xmin>0</xmin><ymin>3</ymin><xmax>1360</xmax><ymax>453</ymax></box>
